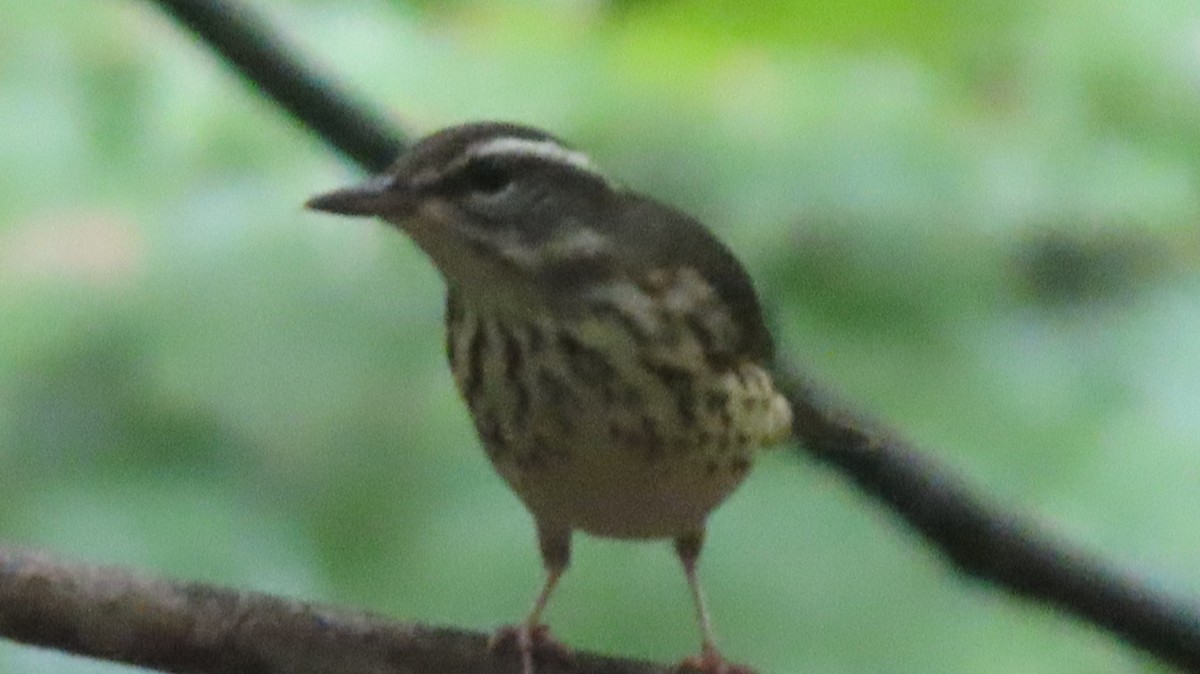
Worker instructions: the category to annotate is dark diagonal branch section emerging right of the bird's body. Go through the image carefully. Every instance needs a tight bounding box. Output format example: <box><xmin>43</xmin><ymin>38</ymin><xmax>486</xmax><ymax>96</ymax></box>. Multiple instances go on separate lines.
<box><xmin>778</xmin><ymin>366</ymin><xmax>1200</xmax><ymax>672</ymax></box>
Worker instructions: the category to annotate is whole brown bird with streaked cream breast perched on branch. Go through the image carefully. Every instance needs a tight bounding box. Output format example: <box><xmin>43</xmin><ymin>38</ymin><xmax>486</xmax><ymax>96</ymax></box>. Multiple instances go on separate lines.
<box><xmin>307</xmin><ymin>122</ymin><xmax>791</xmax><ymax>674</ymax></box>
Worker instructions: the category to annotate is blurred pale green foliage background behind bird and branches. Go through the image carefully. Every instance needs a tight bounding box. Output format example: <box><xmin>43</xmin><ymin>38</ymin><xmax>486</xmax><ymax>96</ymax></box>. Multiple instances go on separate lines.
<box><xmin>0</xmin><ymin>0</ymin><xmax>1200</xmax><ymax>674</ymax></box>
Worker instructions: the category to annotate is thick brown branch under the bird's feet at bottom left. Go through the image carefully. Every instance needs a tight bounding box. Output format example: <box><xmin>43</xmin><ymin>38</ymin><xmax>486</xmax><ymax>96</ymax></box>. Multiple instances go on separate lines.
<box><xmin>0</xmin><ymin>547</ymin><xmax>671</xmax><ymax>674</ymax></box>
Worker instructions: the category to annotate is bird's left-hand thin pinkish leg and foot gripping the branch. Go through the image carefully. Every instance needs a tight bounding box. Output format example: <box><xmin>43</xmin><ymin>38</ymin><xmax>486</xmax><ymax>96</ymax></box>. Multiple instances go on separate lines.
<box><xmin>488</xmin><ymin>524</ymin><xmax>571</xmax><ymax>674</ymax></box>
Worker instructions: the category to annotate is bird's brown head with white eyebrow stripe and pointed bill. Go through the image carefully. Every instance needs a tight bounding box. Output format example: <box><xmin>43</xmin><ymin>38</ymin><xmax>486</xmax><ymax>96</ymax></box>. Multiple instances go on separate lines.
<box><xmin>307</xmin><ymin>122</ymin><xmax>620</xmax><ymax>303</ymax></box>
